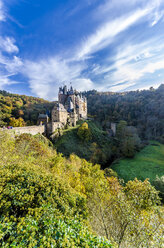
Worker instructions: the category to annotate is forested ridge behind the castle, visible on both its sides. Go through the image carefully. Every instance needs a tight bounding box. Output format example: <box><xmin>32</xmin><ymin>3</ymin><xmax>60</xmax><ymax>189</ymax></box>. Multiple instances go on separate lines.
<box><xmin>0</xmin><ymin>84</ymin><xmax>164</xmax><ymax>143</ymax></box>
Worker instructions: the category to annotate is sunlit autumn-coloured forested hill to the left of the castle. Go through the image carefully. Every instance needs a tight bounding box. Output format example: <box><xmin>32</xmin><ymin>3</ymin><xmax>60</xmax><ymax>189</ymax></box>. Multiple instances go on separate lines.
<box><xmin>0</xmin><ymin>91</ymin><xmax>53</xmax><ymax>127</ymax></box>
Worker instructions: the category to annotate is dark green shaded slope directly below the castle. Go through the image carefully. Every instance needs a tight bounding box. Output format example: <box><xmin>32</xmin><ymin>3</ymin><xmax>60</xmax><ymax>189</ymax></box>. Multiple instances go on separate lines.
<box><xmin>54</xmin><ymin>121</ymin><xmax>111</xmax><ymax>165</ymax></box>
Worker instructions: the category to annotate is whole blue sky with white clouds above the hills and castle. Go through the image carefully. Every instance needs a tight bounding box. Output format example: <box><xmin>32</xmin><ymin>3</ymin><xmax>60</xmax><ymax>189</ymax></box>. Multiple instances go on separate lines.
<box><xmin>0</xmin><ymin>0</ymin><xmax>164</xmax><ymax>100</ymax></box>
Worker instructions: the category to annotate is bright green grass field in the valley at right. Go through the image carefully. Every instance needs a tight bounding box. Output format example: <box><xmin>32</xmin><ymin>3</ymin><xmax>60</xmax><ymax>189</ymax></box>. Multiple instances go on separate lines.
<box><xmin>111</xmin><ymin>142</ymin><xmax>164</xmax><ymax>183</ymax></box>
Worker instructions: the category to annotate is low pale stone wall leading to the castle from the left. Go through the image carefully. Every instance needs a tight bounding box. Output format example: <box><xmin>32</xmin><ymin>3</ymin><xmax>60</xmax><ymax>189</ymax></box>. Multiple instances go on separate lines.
<box><xmin>1</xmin><ymin>125</ymin><xmax>45</xmax><ymax>135</ymax></box>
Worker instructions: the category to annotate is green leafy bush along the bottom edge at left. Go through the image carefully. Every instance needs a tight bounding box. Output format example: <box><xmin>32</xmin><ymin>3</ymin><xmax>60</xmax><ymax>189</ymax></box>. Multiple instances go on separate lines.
<box><xmin>0</xmin><ymin>206</ymin><xmax>111</xmax><ymax>248</ymax></box>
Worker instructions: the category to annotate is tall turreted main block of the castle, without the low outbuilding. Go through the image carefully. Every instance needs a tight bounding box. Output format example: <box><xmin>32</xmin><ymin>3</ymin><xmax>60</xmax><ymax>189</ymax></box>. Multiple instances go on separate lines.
<box><xmin>51</xmin><ymin>86</ymin><xmax>87</xmax><ymax>126</ymax></box>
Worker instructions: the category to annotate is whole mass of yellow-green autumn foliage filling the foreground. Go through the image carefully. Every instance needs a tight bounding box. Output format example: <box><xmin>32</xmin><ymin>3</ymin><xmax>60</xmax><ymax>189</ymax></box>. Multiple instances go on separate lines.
<box><xmin>0</xmin><ymin>131</ymin><xmax>163</xmax><ymax>248</ymax></box>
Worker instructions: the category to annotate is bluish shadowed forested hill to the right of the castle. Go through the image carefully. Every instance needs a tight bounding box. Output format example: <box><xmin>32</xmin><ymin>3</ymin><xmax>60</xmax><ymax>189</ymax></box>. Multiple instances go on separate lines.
<box><xmin>83</xmin><ymin>84</ymin><xmax>164</xmax><ymax>142</ymax></box>
